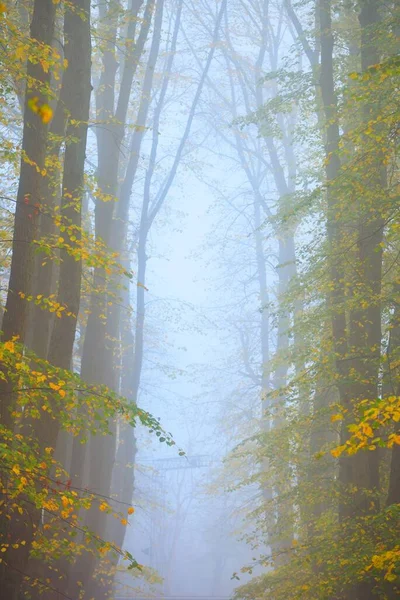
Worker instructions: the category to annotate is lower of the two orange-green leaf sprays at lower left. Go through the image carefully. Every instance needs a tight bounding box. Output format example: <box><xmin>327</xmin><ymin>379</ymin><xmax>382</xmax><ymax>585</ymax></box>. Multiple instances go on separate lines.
<box><xmin>0</xmin><ymin>426</ymin><xmax>134</xmax><ymax>559</ymax></box>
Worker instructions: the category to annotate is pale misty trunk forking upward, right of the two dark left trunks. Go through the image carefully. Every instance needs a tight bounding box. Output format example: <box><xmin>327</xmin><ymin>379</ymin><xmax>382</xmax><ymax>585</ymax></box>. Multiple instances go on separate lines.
<box><xmin>65</xmin><ymin>0</ymin><xmax>155</xmax><ymax>502</ymax></box>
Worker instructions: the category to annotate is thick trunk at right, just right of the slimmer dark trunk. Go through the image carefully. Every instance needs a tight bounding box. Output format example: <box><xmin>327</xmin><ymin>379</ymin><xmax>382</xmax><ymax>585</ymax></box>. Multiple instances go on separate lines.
<box><xmin>350</xmin><ymin>0</ymin><xmax>386</xmax><ymax>512</ymax></box>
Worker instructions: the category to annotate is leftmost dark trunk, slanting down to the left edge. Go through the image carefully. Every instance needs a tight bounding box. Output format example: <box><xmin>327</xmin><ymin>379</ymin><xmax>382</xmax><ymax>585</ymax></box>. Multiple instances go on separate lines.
<box><xmin>0</xmin><ymin>0</ymin><xmax>56</xmax><ymax>600</ymax></box>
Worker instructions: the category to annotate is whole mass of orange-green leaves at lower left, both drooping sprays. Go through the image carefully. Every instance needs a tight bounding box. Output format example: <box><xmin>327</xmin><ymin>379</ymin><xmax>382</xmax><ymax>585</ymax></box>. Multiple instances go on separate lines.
<box><xmin>0</xmin><ymin>340</ymin><xmax>182</xmax><ymax>585</ymax></box>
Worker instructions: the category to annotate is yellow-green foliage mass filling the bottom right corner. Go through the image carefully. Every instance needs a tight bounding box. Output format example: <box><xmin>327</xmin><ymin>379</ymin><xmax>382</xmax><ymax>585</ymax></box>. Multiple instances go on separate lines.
<box><xmin>236</xmin><ymin>506</ymin><xmax>400</xmax><ymax>600</ymax></box>
